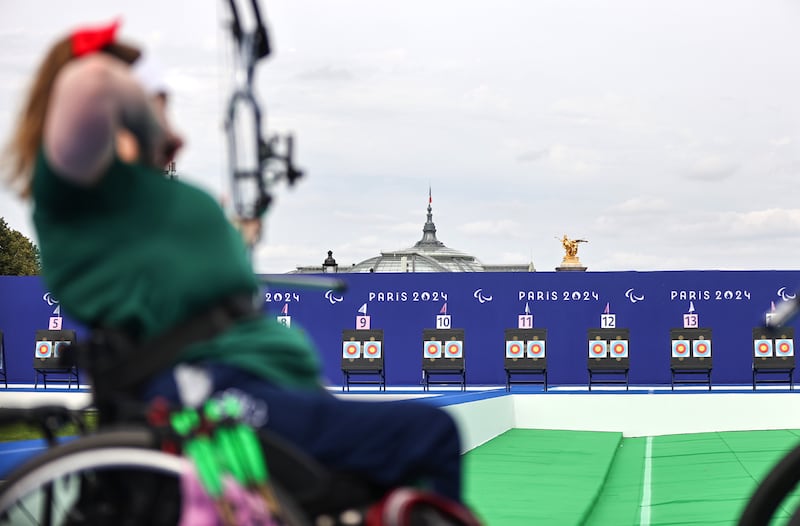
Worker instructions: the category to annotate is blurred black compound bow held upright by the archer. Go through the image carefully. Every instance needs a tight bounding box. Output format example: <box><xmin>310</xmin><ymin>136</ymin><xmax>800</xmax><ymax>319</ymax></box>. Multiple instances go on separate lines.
<box><xmin>225</xmin><ymin>0</ymin><xmax>303</xmax><ymax>219</ymax></box>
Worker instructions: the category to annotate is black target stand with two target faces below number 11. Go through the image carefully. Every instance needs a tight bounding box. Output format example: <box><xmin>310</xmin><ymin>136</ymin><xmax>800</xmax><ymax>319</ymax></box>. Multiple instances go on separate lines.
<box><xmin>503</xmin><ymin>329</ymin><xmax>547</xmax><ymax>391</ymax></box>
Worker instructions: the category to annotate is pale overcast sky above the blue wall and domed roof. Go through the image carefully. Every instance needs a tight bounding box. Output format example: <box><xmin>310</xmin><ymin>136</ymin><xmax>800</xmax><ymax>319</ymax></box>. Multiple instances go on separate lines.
<box><xmin>0</xmin><ymin>0</ymin><xmax>800</xmax><ymax>272</ymax></box>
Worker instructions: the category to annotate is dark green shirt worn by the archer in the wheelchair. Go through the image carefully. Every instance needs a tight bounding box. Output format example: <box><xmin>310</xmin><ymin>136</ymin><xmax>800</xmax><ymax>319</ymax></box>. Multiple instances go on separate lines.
<box><xmin>33</xmin><ymin>152</ymin><xmax>320</xmax><ymax>388</ymax></box>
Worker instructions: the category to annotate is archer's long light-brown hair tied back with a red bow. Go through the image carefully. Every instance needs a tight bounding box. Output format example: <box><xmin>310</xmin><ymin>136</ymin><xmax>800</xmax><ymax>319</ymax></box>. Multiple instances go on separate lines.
<box><xmin>3</xmin><ymin>35</ymin><xmax>141</xmax><ymax>197</ymax></box>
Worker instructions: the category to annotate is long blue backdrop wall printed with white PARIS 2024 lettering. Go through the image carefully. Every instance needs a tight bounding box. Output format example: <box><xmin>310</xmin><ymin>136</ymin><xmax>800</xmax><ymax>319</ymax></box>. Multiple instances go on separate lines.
<box><xmin>0</xmin><ymin>271</ymin><xmax>800</xmax><ymax>386</ymax></box>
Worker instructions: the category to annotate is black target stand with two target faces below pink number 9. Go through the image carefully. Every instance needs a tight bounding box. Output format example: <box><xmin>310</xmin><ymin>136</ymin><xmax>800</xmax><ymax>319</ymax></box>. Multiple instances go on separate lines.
<box><xmin>342</xmin><ymin>329</ymin><xmax>386</xmax><ymax>391</ymax></box>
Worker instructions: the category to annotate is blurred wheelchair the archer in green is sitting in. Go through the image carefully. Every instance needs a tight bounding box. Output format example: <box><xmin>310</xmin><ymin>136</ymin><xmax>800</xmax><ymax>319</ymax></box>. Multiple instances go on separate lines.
<box><xmin>0</xmin><ymin>390</ymin><xmax>479</xmax><ymax>526</ymax></box>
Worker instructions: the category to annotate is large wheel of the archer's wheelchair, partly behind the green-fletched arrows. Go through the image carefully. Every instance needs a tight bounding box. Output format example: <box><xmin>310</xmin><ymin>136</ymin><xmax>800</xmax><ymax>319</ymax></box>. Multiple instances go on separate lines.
<box><xmin>0</xmin><ymin>428</ymin><xmax>309</xmax><ymax>526</ymax></box>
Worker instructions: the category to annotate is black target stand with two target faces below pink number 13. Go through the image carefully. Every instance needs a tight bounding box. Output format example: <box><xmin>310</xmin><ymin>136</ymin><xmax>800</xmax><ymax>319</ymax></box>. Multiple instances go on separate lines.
<box><xmin>669</xmin><ymin>328</ymin><xmax>713</xmax><ymax>391</ymax></box>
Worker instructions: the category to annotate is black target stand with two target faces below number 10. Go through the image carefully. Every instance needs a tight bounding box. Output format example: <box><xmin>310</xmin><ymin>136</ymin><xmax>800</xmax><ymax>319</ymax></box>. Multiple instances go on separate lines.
<box><xmin>422</xmin><ymin>329</ymin><xmax>467</xmax><ymax>391</ymax></box>
